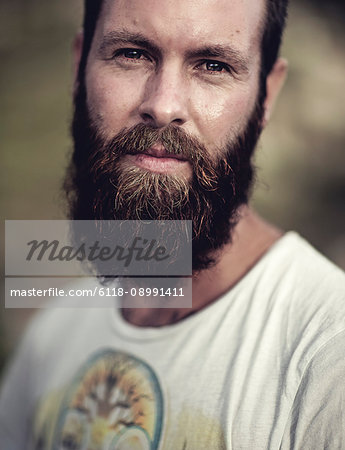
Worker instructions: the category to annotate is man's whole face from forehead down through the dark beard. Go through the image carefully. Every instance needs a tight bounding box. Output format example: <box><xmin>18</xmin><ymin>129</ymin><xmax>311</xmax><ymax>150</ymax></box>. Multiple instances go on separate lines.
<box><xmin>67</xmin><ymin>0</ymin><xmax>264</xmax><ymax>270</ymax></box>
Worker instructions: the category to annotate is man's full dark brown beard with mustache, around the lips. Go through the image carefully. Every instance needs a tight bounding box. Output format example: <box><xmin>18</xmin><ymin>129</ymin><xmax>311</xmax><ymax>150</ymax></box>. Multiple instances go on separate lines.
<box><xmin>64</xmin><ymin>83</ymin><xmax>263</xmax><ymax>273</ymax></box>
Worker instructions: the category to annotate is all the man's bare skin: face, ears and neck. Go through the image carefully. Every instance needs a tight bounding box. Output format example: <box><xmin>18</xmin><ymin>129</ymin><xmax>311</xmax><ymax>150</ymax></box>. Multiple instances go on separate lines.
<box><xmin>75</xmin><ymin>0</ymin><xmax>286</xmax><ymax>326</ymax></box>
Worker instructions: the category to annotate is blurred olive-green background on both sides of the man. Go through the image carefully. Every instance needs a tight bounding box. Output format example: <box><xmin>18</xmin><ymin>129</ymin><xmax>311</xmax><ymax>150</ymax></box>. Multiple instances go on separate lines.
<box><xmin>0</xmin><ymin>0</ymin><xmax>345</xmax><ymax>368</ymax></box>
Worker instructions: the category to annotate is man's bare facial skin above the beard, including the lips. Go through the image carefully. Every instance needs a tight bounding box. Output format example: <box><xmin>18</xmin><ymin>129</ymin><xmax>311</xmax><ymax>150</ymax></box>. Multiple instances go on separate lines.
<box><xmin>86</xmin><ymin>0</ymin><xmax>264</xmax><ymax>166</ymax></box>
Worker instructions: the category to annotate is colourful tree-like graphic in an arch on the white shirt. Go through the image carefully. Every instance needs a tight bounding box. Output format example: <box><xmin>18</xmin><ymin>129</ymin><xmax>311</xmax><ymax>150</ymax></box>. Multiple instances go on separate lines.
<box><xmin>33</xmin><ymin>350</ymin><xmax>163</xmax><ymax>450</ymax></box>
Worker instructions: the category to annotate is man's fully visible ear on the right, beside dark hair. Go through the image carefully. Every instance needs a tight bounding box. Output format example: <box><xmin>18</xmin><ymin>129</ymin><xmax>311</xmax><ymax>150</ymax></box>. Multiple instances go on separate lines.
<box><xmin>263</xmin><ymin>58</ymin><xmax>288</xmax><ymax>126</ymax></box>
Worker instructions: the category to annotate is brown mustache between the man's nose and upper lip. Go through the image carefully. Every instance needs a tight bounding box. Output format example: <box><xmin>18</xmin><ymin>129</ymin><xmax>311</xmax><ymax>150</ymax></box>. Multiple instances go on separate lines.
<box><xmin>89</xmin><ymin>124</ymin><xmax>232</xmax><ymax>190</ymax></box>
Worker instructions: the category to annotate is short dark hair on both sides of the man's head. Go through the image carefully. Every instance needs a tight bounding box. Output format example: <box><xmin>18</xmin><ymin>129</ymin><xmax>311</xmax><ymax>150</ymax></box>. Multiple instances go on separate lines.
<box><xmin>79</xmin><ymin>0</ymin><xmax>289</xmax><ymax>96</ymax></box>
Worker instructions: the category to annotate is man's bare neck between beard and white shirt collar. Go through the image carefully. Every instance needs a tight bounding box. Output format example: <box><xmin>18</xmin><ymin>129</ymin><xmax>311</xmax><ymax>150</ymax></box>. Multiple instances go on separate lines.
<box><xmin>122</xmin><ymin>206</ymin><xmax>283</xmax><ymax>327</ymax></box>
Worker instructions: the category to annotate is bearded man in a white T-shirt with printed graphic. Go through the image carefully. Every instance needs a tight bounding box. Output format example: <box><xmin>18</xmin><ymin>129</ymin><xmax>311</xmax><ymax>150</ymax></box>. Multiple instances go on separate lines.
<box><xmin>0</xmin><ymin>0</ymin><xmax>345</xmax><ymax>450</ymax></box>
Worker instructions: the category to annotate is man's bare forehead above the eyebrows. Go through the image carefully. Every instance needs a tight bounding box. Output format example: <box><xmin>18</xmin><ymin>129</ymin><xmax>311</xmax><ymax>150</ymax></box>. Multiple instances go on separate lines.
<box><xmin>96</xmin><ymin>0</ymin><xmax>265</xmax><ymax>53</ymax></box>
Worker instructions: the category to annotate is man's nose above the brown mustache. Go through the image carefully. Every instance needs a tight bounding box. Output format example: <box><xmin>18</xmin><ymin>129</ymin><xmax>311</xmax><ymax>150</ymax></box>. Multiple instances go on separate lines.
<box><xmin>139</xmin><ymin>63</ymin><xmax>188</xmax><ymax>128</ymax></box>
